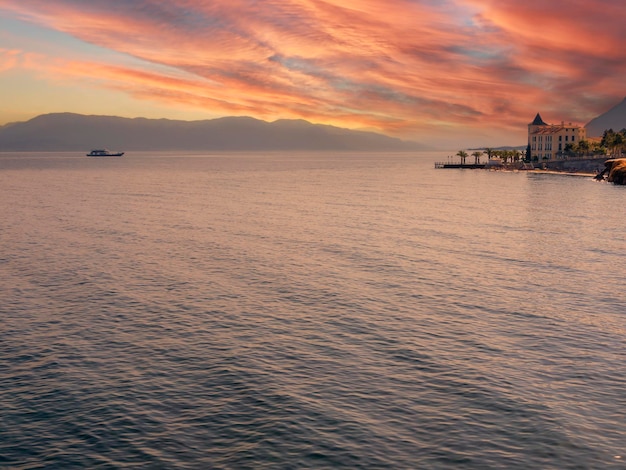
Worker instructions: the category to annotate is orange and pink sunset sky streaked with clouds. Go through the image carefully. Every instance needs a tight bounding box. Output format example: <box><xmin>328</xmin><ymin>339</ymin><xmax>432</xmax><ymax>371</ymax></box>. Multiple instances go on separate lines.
<box><xmin>0</xmin><ymin>0</ymin><xmax>626</xmax><ymax>148</ymax></box>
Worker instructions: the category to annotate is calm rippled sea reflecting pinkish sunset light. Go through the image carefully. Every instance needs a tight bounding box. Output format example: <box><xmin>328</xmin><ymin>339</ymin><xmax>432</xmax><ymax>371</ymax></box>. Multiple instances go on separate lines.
<box><xmin>0</xmin><ymin>153</ymin><xmax>626</xmax><ymax>469</ymax></box>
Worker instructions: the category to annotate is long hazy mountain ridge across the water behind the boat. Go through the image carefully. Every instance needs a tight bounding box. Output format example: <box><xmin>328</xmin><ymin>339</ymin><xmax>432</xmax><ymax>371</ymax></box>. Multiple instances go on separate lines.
<box><xmin>0</xmin><ymin>113</ymin><xmax>424</xmax><ymax>152</ymax></box>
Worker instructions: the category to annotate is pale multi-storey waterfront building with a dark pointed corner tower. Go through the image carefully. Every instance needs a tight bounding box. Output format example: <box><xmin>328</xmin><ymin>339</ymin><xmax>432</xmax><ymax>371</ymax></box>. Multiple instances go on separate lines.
<box><xmin>528</xmin><ymin>113</ymin><xmax>587</xmax><ymax>161</ymax></box>
